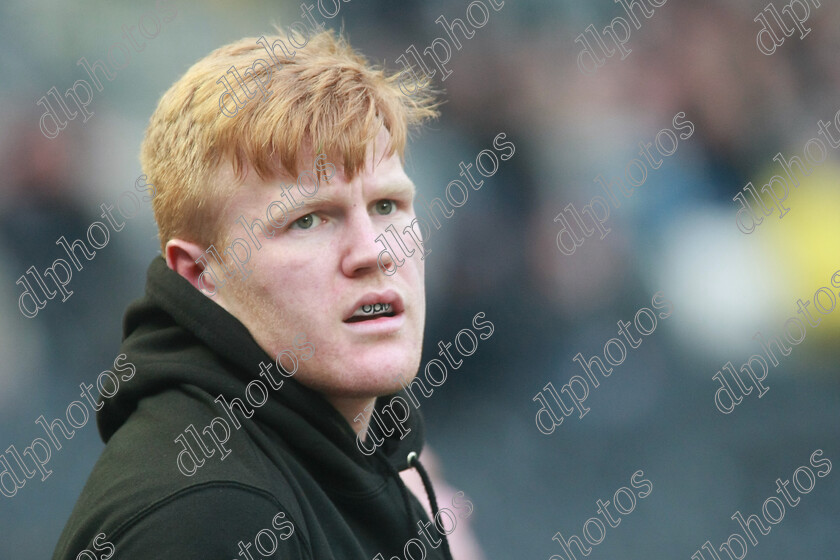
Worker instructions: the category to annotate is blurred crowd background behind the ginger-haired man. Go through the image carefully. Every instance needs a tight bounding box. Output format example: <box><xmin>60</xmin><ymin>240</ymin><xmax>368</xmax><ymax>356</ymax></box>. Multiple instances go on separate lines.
<box><xmin>0</xmin><ymin>0</ymin><xmax>840</xmax><ymax>560</ymax></box>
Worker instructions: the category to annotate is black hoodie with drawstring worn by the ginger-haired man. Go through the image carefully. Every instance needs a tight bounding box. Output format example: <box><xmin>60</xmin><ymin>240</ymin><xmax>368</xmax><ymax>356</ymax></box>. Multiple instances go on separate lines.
<box><xmin>53</xmin><ymin>257</ymin><xmax>449</xmax><ymax>560</ymax></box>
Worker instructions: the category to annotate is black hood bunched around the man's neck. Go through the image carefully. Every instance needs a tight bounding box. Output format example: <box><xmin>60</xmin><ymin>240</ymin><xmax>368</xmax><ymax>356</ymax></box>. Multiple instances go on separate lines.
<box><xmin>97</xmin><ymin>256</ymin><xmax>423</xmax><ymax>476</ymax></box>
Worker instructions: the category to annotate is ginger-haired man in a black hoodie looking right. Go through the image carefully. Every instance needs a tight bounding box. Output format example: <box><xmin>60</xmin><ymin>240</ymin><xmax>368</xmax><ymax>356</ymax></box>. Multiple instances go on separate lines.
<box><xmin>54</xmin><ymin>32</ymin><xmax>460</xmax><ymax>560</ymax></box>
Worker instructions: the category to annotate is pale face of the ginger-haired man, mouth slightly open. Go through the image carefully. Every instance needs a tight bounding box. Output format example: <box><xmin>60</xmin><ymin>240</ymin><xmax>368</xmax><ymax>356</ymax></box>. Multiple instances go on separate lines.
<box><xmin>214</xmin><ymin>129</ymin><xmax>426</xmax><ymax>399</ymax></box>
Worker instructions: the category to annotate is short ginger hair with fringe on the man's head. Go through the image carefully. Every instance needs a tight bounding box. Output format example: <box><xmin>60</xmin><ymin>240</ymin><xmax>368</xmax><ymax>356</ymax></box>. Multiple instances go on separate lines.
<box><xmin>140</xmin><ymin>29</ymin><xmax>439</xmax><ymax>251</ymax></box>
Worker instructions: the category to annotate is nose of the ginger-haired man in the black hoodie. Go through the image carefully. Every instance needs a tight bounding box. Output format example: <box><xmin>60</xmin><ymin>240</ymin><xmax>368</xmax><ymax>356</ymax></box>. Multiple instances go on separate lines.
<box><xmin>341</xmin><ymin>208</ymin><xmax>396</xmax><ymax>277</ymax></box>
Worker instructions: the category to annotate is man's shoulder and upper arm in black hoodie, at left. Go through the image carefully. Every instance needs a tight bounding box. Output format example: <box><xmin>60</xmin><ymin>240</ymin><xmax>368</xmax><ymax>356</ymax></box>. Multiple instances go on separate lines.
<box><xmin>55</xmin><ymin>386</ymin><xmax>311</xmax><ymax>560</ymax></box>
